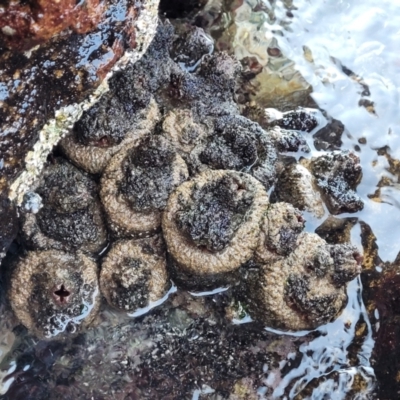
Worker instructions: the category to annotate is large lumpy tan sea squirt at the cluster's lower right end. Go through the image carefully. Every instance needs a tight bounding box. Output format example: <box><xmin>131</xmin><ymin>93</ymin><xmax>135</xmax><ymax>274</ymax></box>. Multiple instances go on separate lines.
<box><xmin>243</xmin><ymin>233</ymin><xmax>361</xmax><ymax>331</ymax></box>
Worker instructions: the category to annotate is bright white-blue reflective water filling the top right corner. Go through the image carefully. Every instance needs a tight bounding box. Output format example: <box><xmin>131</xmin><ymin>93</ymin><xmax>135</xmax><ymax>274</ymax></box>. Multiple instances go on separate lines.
<box><xmin>225</xmin><ymin>0</ymin><xmax>400</xmax><ymax>261</ymax></box>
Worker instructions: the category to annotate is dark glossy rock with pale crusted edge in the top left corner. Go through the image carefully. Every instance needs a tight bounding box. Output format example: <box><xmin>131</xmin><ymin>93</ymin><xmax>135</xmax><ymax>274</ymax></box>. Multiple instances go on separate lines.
<box><xmin>0</xmin><ymin>0</ymin><xmax>158</xmax><ymax>202</ymax></box>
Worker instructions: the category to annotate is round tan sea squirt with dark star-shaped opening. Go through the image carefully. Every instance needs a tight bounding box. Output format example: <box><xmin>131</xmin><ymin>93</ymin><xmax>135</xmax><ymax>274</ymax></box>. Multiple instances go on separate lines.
<box><xmin>9</xmin><ymin>250</ymin><xmax>100</xmax><ymax>339</ymax></box>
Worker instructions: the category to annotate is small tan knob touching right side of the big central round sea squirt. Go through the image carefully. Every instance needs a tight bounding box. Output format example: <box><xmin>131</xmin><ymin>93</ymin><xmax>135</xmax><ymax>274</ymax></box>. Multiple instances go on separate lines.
<box><xmin>255</xmin><ymin>203</ymin><xmax>305</xmax><ymax>263</ymax></box>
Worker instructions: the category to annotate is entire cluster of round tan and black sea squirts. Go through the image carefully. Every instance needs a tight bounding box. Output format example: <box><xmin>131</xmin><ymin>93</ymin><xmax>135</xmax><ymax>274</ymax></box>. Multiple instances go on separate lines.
<box><xmin>9</xmin><ymin>21</ymin><xmax>362</xmax><ymax>338</ymax></box>
